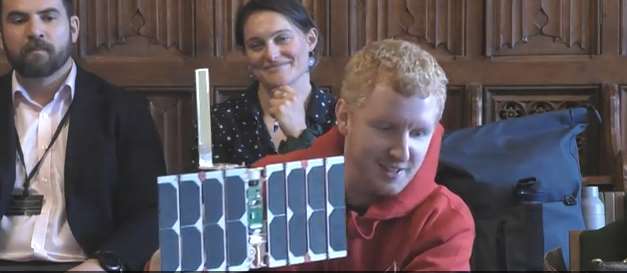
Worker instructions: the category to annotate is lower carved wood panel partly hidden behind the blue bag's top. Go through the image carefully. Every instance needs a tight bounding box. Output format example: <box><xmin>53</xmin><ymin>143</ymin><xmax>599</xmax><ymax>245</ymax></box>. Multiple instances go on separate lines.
<box><xmin>484</xmin><ymin>86</ymin><xmax>603</xmax><ymax>175</ymax></box>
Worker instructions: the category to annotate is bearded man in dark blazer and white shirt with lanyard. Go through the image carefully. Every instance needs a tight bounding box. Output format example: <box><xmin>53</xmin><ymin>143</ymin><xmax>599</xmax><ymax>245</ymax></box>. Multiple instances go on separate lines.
<box><xmin>0</xmin><ymin>0</ymin><xmax>165</xmax><ymax>272</ymax></box>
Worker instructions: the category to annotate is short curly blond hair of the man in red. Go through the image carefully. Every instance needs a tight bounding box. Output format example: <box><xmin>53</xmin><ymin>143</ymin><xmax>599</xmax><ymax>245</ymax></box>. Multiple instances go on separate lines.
<box><xmin>340</xmin><ymin>39</ymin><xmax>448</xmax><ymax>117</ymax></box>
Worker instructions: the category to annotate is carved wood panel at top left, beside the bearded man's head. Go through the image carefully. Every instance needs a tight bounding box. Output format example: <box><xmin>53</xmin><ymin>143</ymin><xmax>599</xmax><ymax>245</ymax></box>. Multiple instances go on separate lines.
<box><xmin>78</xmin><ymin>0</ymin><xmax>194</xmax><ymax>58</ymax></box>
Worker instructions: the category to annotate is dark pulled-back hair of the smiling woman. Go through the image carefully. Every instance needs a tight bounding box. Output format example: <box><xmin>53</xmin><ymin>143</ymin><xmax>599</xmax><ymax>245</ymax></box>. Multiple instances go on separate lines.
<box><xmin>235</xmin><ymin>0</ymin><xmax>320</xmax><ymax>50</ymax></box>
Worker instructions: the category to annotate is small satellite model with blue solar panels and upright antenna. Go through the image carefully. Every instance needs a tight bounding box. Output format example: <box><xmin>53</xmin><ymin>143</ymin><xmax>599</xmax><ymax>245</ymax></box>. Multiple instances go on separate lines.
<box><xmin>158</xmin><ymin>69</ymin><xmax>347</xmax><ymax>271</ymax></box>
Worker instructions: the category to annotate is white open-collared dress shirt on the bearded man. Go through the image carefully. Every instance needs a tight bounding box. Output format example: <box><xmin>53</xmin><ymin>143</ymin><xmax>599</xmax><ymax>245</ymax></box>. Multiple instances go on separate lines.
<box><xmin>0</xmin><ymin>64</ymin><xmax>86</xmax><ymax>262</ymax></box>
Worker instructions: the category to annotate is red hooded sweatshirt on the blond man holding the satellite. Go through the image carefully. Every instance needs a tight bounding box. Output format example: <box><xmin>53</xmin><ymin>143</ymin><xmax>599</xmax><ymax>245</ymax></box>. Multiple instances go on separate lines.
<box><xmin>254</xmin><ymin>125</ymin><xmax>475</xmax><ymax>271</ymax></box>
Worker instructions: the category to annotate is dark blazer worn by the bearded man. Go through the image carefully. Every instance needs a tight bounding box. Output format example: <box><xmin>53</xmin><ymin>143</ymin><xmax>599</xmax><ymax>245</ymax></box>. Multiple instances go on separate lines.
<box><xmin>0</xmin><ymin>68</ymin><xmax>165</xmax><ymax>269</ymax></box>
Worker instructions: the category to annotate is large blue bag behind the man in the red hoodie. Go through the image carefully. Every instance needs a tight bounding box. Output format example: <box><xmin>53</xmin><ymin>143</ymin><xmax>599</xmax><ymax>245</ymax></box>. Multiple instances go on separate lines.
<box><xmin>436</xmin><ymin>105</ymin><xmax>596</xmax><ymax>270</ymax></box>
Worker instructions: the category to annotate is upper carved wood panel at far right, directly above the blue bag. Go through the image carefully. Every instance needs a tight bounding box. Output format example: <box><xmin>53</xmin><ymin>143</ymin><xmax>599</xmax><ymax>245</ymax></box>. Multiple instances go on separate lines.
<box><xmin>485</xmin><ymin>0</ymin><xmax>602</xmax><ymax>56</ymax></box>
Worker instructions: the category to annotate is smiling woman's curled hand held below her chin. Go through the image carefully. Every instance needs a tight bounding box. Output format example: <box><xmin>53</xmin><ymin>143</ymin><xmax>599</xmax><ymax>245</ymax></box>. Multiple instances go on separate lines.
<box><xmin>268</xmin><ymin>85</ymin><xmax>307</xmax><ymax>138</ymax></box>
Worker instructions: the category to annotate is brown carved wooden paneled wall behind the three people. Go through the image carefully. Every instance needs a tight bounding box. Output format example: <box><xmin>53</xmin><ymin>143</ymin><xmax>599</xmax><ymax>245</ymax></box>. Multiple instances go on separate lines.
<box><xmin>1</xmin><ymin>0</ymin><xmax>627</xmax><ymax>189</ymax></box>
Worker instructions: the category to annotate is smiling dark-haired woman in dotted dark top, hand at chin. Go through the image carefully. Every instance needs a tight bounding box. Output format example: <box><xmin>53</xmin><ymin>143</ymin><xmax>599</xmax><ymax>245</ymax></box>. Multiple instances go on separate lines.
<box><xmin>211</xmin><ymin>0</ymin><xmax>336</xmax><ymax>164</ymax></box>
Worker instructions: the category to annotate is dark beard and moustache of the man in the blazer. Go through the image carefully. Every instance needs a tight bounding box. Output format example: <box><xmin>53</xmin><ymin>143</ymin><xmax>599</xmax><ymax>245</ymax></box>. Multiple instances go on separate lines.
<box><xmin>4</xmin><ymin>39</ymin><xmax>72</xmax><ymax>78</ymax></box>
